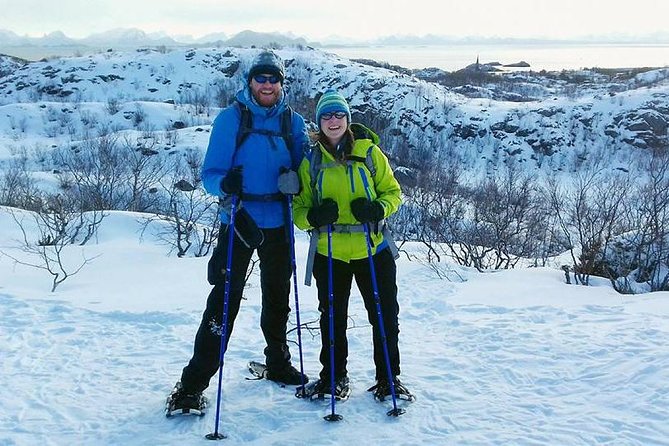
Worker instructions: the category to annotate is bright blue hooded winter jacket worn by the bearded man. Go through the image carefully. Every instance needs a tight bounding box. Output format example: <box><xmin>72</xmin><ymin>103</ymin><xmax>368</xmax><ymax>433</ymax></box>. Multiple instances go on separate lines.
<box><xmin>202</xmin><ymin>87</ymin><xmax>308</xmax><ymax>228</ymax></box>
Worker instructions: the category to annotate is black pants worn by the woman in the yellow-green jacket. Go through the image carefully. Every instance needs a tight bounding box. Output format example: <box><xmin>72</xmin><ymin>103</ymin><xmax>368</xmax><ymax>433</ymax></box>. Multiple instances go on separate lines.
<box><xmin>314</xmin><ymin>248</ymin><xmax>400</xmax><ymax>380</ymax></box>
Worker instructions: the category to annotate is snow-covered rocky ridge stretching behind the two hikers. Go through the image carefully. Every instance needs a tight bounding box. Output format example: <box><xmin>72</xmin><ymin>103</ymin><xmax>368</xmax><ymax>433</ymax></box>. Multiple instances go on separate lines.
<box><xmin>0</xmin><ymin>48</ymin><xmax>669</xmax><ymax>182</ymax></box>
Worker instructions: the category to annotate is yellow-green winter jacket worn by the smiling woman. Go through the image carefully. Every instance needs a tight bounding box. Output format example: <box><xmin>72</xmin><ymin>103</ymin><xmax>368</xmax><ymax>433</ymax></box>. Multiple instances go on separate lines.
<box><xmin>293</xmin><ymin>124</ymin><xmax>401</xmax><ymax>262</ymax></box>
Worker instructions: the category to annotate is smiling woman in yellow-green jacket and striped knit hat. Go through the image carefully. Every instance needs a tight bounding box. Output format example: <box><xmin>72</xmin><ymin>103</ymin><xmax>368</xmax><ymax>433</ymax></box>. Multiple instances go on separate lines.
<box><xmin>294</xmin><ymin>91</ymin><xmax>410</xmax><ymax>400</ymax></box>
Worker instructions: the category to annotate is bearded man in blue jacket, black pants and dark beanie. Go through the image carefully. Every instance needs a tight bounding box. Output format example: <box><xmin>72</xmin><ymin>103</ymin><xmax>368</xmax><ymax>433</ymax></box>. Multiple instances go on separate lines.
<box><xmin>166</xmin><ymin>51</ymin><xmax>308</xmax><ymax>416</ymax></box>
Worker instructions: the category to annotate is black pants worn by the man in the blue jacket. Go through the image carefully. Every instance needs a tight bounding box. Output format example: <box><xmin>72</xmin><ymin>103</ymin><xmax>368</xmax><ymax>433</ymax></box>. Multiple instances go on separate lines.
<box><xmin>181</xmin><ymin>227</ymin><xmax>292</xmax><ymax>392</ymax></box>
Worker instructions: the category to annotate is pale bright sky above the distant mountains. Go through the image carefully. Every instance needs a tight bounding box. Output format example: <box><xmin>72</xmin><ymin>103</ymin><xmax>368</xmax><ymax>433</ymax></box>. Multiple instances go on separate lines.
<box><xmin>0</xmin><ymin>0</ymin><xmax>669</xmax><ymax>40</ymax></box>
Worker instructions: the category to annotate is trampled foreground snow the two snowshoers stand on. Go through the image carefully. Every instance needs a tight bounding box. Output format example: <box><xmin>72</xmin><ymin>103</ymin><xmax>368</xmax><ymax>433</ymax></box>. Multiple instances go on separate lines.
<box><xmin>0</xmin><ymin>208</ymin><xmax>669</xmax><ymax>445</ymax></box>
